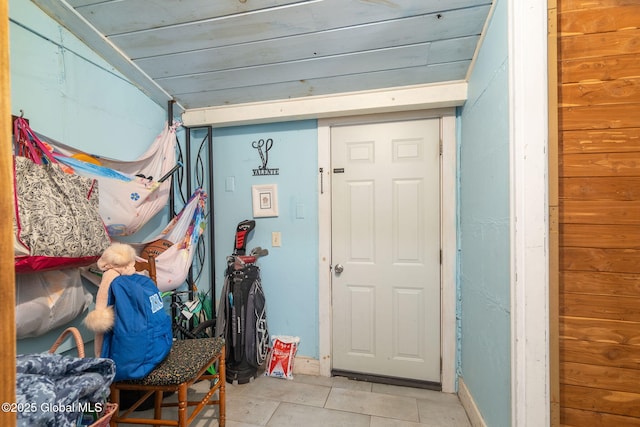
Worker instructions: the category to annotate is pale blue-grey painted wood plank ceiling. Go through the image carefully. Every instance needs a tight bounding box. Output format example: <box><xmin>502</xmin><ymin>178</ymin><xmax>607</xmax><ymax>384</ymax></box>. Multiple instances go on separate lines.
<box><xmin>33</xmin><ymin>0</ymin><xmax>492</xmax><ymax>110</ymax></box>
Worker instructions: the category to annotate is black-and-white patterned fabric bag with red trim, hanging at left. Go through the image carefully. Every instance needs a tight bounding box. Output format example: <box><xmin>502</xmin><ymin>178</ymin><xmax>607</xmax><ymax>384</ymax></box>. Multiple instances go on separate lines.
<box><xmin>13</xmin><ymin>119</ymin><xmax>110</xmax><ymax>272</ymax></box>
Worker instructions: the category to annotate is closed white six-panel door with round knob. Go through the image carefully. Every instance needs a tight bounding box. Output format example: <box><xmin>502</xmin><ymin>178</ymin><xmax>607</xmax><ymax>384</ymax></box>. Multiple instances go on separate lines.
<box><xmin>331</xmin><ymin>118</ymin><xmax>441</xmax><ymax>383</ymax></box>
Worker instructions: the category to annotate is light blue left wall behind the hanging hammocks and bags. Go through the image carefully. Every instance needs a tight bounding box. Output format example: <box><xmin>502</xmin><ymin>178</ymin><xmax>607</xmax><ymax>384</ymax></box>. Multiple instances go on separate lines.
<box><xmin>9</xmin><ymin>0</ymin><xmax>168</xmax><ymax>354</ymax></box>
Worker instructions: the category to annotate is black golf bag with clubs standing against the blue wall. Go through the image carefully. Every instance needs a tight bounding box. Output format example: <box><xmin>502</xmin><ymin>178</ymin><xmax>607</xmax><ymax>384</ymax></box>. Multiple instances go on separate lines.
<box><xmin>216</xmin><ymin>223</ymin><xmax>269</xmax><ymax>384</ymax></box>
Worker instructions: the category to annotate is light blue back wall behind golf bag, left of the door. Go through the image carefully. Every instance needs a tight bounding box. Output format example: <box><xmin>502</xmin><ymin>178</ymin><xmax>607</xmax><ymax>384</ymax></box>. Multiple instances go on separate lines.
<box><xmin>213</xmin><ymin>120</ymin><xmax>319</xmax><ymax>359</ymax></box>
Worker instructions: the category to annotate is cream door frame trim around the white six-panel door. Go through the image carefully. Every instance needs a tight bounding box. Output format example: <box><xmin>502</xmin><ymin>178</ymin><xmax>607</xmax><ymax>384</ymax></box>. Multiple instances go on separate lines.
<box><xmin>318</xmin><ymin>108</ymin><xmax>458</xmax><ymax>393</ymax></box>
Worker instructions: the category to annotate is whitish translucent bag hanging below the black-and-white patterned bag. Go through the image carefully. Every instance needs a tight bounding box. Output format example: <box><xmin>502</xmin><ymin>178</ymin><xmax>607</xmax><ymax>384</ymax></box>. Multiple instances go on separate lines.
<box><xmin>16</xmin><ymin>268</ymin><xmax>93</xmax><ymax>338</ymax></box>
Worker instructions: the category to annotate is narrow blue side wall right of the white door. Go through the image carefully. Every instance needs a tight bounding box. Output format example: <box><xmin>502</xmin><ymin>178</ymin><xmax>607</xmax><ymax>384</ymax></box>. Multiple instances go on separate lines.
<box><xmin>458</xmin><ymin>0</ymin><xmax>511</xmax><ymax>427</ymax></box>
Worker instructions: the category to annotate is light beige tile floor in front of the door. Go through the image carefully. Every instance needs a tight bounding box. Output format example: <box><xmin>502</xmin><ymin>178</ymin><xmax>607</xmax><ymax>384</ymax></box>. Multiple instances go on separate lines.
<box><xmin>121</xmin><ymin>374</ymin><xmax>471</xmax><ymax>427</ymax></box>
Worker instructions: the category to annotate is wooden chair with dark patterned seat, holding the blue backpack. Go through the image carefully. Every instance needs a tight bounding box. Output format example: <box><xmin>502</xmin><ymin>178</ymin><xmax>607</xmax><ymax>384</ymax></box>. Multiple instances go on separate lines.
<box><xmin>110</xmin><ymin>257</ymin><xmax>226</xmax><ymax>427</ymax></box>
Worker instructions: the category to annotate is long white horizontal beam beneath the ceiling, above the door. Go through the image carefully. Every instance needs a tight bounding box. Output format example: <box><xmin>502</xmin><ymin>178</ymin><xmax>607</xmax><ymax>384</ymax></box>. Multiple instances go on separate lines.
<box><xmin>182</xmin><ymin>81</ymin><xmax>467</xmax><ymax>127</ymax></box>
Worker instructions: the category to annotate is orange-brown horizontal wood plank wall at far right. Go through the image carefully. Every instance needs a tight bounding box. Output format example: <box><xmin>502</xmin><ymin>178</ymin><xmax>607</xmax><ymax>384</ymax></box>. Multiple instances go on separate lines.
<box><xmin>556</xmin><ymin>0</ymin><xmax>640</xmax><ymax>427</ymax></box>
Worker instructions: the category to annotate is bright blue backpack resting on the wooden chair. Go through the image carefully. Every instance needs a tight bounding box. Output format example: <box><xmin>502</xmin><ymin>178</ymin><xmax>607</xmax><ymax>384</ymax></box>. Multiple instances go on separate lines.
<box><xmin>101</xmin><ymin>274</ymin><xmax>173</xmax><ymax>381</ymax></box>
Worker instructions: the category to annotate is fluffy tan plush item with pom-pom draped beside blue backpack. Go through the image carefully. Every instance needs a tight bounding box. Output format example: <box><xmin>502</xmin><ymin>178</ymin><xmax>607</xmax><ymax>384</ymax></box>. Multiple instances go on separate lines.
<box><xmin>84</xmin><ymin>243</ymin><xmax>136</xmax><ymax>357</ymax></box>
